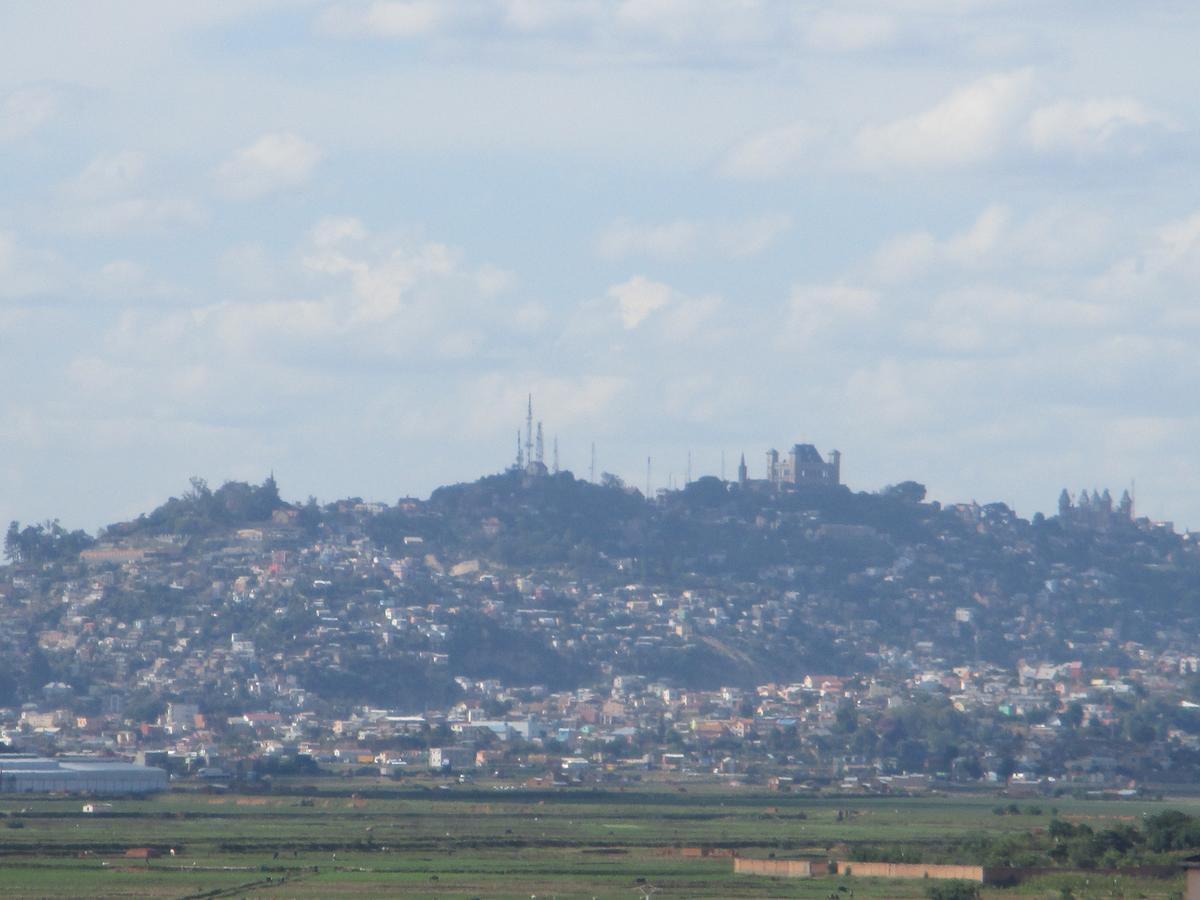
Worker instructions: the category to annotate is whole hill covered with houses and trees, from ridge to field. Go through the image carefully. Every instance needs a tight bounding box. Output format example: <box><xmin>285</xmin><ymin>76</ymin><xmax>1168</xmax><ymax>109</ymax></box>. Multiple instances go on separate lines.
<box><xmin>0</xmin><ymin>468</ymin><xmax>1200</xmax><ymax>790</ymax></box>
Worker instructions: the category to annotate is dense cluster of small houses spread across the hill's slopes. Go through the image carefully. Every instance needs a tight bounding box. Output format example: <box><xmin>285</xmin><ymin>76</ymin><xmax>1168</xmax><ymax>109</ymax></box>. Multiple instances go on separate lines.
<box><xmin>0</xmin><ymin>482</ymin><xmax>1200</xmax><ymax>790</ymax></box>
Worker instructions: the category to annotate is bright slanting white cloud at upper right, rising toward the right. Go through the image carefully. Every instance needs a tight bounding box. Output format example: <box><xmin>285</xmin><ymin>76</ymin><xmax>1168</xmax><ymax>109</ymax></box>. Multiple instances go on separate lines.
<box><xmin>854</xmin><ymin>70</ymin><xmax>1033</xmax><ymax>169</ymax></box>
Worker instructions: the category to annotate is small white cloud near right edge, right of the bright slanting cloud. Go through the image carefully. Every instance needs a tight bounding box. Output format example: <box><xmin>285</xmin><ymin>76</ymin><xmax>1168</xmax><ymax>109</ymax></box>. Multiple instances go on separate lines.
<box><xmin>1026</xmin><ymin>98</ymin><xmax>1171</xmax><ymax>155</ymax></box>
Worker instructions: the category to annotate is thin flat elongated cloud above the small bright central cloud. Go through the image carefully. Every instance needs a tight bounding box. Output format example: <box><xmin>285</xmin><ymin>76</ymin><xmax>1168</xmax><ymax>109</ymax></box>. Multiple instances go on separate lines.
<box><xmin>596</xmin><ymin>214</ymin><xmax>792</xmax><ymax>260</ymax></box>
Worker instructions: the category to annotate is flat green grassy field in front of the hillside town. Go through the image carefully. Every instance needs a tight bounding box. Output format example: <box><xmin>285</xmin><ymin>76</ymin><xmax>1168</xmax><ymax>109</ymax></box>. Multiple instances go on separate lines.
<box><xmin>0</xmin><ymin>779</ymin><xmax>1200</xmax><ymax>898</ymax></box>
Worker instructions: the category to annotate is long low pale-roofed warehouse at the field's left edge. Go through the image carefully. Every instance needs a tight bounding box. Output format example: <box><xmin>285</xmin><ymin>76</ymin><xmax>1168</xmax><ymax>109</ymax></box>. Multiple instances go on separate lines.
<box><xmin>0</xmin><ymin>755</ymin><xmax>167</xmax><ymax>794</ymax></box>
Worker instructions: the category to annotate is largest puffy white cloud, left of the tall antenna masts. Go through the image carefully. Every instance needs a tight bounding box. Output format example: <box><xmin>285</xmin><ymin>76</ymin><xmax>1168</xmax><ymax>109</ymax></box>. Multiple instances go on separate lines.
<box><xmin>97</xmin><ymin>218</ymin><xmax>533</xmax><ymax>388</ymax></box>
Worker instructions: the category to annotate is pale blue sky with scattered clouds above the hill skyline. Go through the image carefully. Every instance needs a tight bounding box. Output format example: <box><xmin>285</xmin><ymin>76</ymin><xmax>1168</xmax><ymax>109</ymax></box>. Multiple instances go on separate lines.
<box><xmin>0</xmin><ymin>0</ymin><xmax>1200</xmax><ymax>530</ymax></box>
